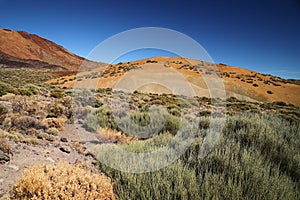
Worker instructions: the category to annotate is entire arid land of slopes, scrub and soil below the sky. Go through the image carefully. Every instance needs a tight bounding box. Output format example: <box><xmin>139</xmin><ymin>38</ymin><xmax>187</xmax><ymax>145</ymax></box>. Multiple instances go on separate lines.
<box><xmin>0</xmin><ymin>29</ymin><xmax>300</xmax><ymax>199</ymax></box>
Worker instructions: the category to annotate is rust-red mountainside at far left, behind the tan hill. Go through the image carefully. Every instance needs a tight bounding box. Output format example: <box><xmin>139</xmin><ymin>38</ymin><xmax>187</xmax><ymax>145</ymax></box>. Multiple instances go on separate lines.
<box><xmin>0</xmin><ymin>29</ymin><xmax>101</xmax><ymax>71</ymax></box>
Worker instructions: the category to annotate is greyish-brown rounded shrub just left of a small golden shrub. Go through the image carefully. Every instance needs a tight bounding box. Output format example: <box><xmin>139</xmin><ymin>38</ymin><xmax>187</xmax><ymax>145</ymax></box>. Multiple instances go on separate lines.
<box><xmin>13</xmin><ymin>116</ymin><xmax>48</xmax><ymax>133</ymax></box>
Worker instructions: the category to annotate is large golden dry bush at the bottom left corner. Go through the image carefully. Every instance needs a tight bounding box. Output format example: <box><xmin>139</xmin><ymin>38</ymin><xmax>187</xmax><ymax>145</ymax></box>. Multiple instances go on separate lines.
<box><xmin>11</xmin><ymin>162</ymin><xmax>115</xmax><ymax>200</ymax></box>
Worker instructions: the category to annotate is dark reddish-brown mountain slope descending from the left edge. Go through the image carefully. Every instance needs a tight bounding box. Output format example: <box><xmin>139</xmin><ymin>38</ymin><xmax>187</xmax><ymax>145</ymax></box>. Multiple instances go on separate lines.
<box><xmin>0</xmin><ymin>28</ymin><xmax>103</xmax><ymax>71</ymax></box>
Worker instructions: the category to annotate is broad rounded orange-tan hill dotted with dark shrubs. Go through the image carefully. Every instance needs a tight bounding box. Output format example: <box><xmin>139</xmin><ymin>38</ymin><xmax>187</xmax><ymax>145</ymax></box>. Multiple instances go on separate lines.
<box><xmin>50</xmin><ymin>57</ymin><xmax>300</xmax><ymax>105</ymax></box>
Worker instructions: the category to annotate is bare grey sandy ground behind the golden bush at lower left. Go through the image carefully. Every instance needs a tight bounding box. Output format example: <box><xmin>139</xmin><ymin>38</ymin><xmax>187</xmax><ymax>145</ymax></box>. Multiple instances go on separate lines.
<box><xmin>0</xmin><ymin>124</ymin><xmax>99</xmax><ymax>199</ymax></box>
